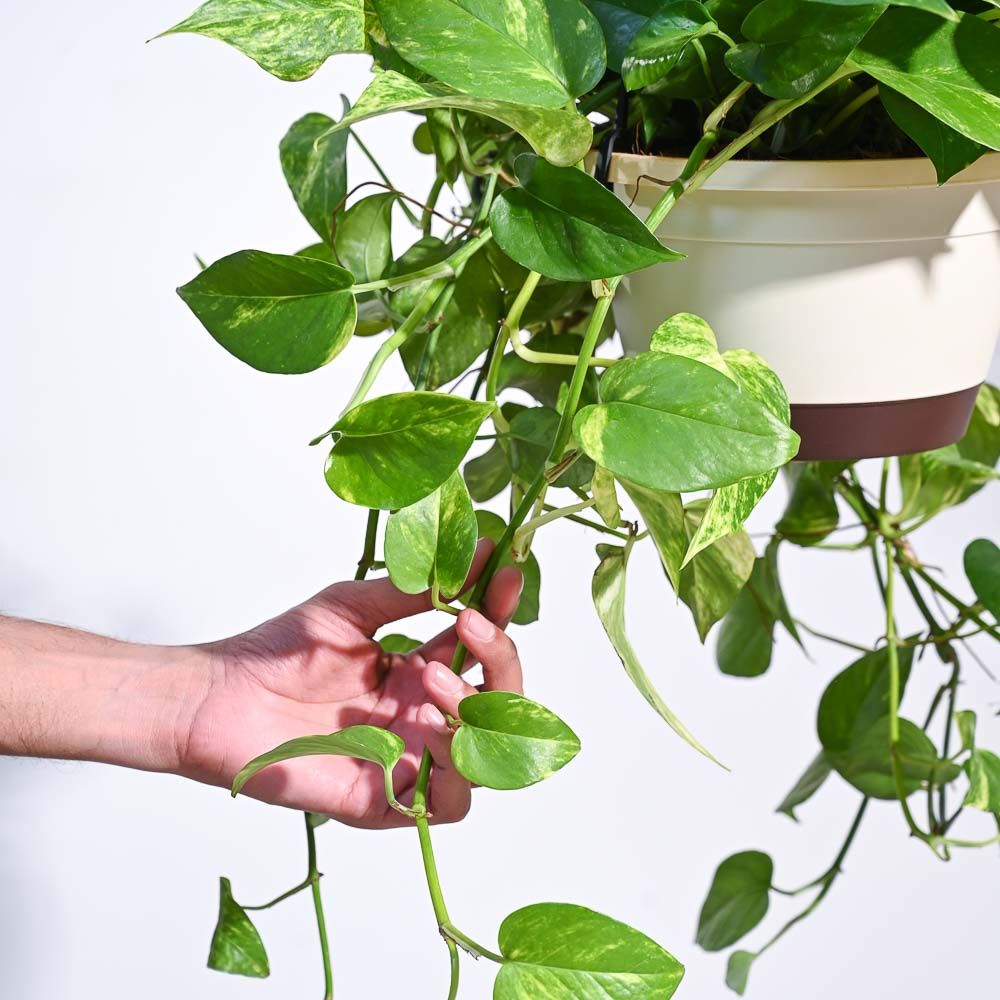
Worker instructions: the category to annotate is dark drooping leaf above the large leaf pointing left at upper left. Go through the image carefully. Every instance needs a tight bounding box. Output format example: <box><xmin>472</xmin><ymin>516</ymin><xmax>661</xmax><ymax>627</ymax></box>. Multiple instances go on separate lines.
<box><xmin>279</xmin><ymin>112</ymin><xmax>350</xmax><ymax>246</ymax></box>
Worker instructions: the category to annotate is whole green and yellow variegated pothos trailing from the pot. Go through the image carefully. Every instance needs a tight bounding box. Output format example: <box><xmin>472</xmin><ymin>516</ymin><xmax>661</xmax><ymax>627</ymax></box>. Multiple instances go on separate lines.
<box><xmin>158</xmin><ymin>0</ymin><xmax>1000</xmax><ymax>1000</ymax></box>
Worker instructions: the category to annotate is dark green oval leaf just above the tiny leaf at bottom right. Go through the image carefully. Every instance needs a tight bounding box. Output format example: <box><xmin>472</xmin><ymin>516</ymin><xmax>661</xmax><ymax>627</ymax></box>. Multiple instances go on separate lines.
<box><xmin>698</xmin><ymin>851</ymin><xmax>774</xmax><ymax>951</ymax></box>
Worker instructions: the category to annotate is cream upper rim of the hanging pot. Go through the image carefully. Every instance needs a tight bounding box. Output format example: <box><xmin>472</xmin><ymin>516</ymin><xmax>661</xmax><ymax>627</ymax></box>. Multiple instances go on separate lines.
<box><xmin>608</xmin><ymin>152</ymin><xmax>1000</xmax><ymax>194</ymax></box>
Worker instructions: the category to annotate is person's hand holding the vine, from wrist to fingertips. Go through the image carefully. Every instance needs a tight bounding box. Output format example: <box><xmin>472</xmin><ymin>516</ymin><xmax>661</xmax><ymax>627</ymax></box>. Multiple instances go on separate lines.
<box><xmin>178</xmin><ymin>542</ymin><xmax>522</xmax><ymax>828</ymax></box>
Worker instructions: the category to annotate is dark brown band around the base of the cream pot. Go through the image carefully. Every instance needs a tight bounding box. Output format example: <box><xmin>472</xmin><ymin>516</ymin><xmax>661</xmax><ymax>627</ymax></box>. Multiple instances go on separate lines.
<box><xmin>792</xmin><ymin>385</ymin><xmax>979</xmax><ymax>462</ymax></box>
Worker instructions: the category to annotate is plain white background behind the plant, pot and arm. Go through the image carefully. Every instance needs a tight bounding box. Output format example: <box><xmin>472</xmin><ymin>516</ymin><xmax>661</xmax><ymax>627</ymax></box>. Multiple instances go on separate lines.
<box><xmin>0</xmin><ymin>7</ymin><xmax>1000</xmax><ymax>1000</ymax></box>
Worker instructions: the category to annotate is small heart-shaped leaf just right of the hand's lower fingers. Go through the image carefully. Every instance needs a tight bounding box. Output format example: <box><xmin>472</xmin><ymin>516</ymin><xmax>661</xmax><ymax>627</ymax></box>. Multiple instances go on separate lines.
<box><xmin>451</xmin><ymin>691</ymin><xmax>580</xmax><ymax>791</ymax></box>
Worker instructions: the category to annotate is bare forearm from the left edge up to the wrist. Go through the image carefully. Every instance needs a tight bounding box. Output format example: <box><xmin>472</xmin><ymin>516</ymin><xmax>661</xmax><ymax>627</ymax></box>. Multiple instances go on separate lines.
<box><xmin>0</xmin><ymin>617</ymin><xmax>211</xmax><ymax>771</ymax></box>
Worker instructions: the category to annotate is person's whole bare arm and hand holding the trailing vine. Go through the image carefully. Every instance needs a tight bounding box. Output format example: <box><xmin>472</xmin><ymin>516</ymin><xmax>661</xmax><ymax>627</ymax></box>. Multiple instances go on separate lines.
<box><xmin>0</xmin><ymin>542</ymin><xmax>522</xmax><ymax>829</ymax></box>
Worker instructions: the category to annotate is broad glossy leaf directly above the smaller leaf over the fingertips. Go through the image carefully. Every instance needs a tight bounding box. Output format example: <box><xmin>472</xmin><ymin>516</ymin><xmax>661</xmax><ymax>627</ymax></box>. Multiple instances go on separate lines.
<box><xmin>326</xmin><ymin>392</ymin><xmax>494</xmax><ymax>510</ymax></box>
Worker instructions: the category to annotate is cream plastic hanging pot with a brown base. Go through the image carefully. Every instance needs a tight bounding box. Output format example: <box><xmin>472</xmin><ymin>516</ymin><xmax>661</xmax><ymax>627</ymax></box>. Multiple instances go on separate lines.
<box><xmin>609</xmin><ymin>153</ymin><xmax>1000</xmax><ymax>460</ymax></box>
